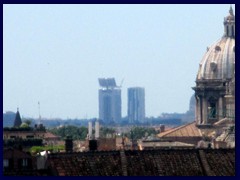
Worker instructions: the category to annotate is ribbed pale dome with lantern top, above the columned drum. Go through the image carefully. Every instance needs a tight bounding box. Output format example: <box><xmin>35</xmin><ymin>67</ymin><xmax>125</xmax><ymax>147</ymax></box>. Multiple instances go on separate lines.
<box><xmin>197</xmin><ymin>7</ymin><xmax>235</xmax><ymax>80</ymax></box>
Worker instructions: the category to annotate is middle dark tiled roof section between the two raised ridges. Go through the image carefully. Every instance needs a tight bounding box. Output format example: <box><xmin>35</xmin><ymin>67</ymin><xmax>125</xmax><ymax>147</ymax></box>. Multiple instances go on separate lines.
<box><xmin>126</xmin><ymin>150</ymin><xmax>204</xmax><ymax>176</ymax></box>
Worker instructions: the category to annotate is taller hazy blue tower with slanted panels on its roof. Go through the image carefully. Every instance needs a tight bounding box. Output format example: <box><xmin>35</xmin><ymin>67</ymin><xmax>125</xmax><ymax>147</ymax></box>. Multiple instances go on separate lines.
<box><xmin>98</xmin><ymin>78</ymin><xmax>122</xmax><ymax>124</ymax></box>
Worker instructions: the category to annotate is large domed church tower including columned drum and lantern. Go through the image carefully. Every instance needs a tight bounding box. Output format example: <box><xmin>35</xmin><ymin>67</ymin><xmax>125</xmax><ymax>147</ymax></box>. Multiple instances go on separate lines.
<box><xmin>193</xmin><ymin>7</ymin><xmax>235</xmax><ymax>126</ymax></box>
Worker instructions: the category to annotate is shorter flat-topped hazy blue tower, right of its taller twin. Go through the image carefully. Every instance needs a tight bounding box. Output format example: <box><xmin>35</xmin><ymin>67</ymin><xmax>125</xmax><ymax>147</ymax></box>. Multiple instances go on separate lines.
<box><xmin>128</xmin><ymin>87</ymin><xmax>145</xmax><ymax>123</ymax></box>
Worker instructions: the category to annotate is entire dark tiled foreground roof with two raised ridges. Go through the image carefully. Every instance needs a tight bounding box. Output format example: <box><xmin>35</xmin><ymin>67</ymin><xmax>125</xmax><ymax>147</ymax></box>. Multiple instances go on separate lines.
<box><xmin>48</xmin><ymin>149</ymin><xmax>235</xmax><ymax>176</ymax></box>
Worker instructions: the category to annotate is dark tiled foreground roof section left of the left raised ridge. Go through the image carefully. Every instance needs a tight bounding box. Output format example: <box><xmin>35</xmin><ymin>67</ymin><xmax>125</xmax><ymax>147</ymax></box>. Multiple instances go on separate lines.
<box><xmin>48</xmin><ymin>151</ymin><xmax>123</xmax><ymax>176</ymax></box>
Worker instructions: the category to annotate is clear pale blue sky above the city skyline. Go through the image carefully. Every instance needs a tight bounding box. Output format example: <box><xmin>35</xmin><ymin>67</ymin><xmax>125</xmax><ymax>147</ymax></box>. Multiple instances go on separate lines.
<box><xmin>3</xmin><ymin>4</ymin><xmax>235</xmax><ymax>118</ymax></box>
